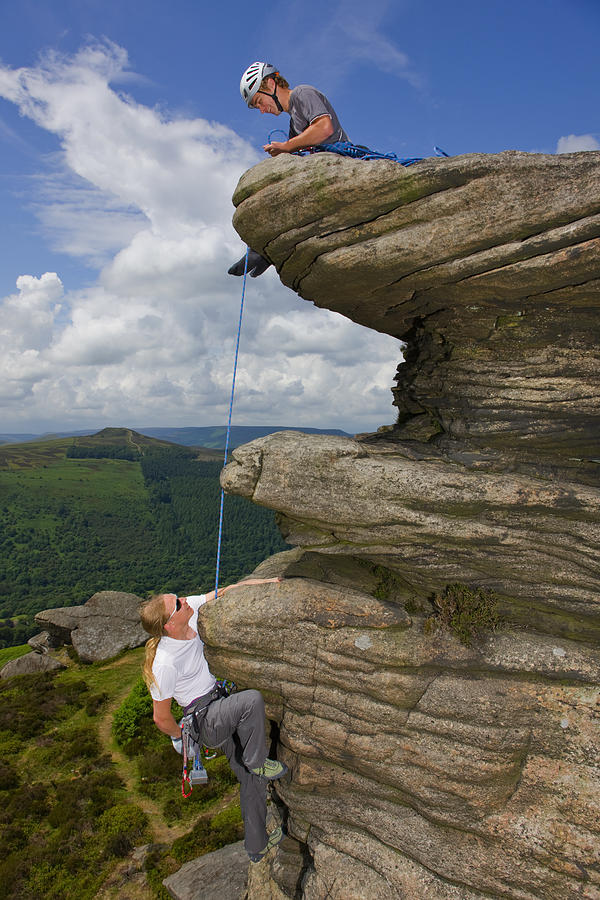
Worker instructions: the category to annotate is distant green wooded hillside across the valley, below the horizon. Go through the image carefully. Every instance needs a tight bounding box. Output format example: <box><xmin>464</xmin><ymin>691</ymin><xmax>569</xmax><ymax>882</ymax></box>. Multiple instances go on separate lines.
<box><xmin>0</xmin><ymin>429</ymin><xmax>286</xmax><ymax>646</ymax></box>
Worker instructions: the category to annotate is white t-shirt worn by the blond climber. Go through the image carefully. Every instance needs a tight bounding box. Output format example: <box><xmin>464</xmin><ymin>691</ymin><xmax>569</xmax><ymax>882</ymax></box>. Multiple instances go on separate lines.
<box><xmin>150</xmin><ymin>594</ymin><xmax>216</xmax><ymax>707</ymax></box>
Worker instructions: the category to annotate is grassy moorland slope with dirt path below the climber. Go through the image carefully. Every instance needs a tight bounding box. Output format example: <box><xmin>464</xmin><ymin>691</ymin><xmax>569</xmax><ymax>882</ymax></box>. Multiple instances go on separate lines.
<box><xmin>0</xmin><ymin>649</ymin><xmax>243</xmax><ymax>900</ymax></box>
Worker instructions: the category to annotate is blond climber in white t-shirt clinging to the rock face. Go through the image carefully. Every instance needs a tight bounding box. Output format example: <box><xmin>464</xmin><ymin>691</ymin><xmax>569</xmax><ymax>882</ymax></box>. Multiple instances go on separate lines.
<box><xmin>140</xmin><ymin>578</ymin><xmax>287</xmax><ymax>862</ymax></box>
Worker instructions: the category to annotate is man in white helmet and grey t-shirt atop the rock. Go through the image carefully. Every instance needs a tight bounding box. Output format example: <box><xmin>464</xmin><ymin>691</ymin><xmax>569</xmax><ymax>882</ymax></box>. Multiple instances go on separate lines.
<box><xmin>240</xmin><ymin>62</ymin><xmax>348</xmax><ymax>156</ymax></box>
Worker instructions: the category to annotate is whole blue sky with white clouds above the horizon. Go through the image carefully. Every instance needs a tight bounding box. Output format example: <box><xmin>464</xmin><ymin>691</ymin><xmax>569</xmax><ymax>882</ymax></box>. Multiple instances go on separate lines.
<box><xmin>0</xmin><ymin>0</ymin><xmax>600</xmax><ymax>431</ymax></box>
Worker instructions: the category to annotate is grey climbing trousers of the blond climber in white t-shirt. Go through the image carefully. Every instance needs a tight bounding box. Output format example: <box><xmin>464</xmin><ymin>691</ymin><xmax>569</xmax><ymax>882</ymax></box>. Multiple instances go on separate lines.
<box><xmin>198</xmin><ymin>690</ymin><xmax>268</xmax><ymax>853</ymax></box>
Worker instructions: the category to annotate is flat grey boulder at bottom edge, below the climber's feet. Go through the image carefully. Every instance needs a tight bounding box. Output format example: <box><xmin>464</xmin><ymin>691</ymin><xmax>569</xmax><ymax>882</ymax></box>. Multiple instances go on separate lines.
<box><xmin>163</xmin><ymin>841</ymin><xmax>249</xmax><ymax>900</ymax></box>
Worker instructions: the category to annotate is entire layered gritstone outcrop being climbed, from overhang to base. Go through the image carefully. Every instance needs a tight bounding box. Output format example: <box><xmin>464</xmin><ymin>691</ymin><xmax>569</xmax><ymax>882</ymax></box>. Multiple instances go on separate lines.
<box><xmin>200</xmin><ymin>153</ymin><xmax>600</xmax><ymax>900</ymax></box>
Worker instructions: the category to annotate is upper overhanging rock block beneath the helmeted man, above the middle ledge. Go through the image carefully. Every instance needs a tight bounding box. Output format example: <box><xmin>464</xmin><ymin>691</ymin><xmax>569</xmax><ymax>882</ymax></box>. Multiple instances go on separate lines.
<box><xmin>234</xmin><ymin>152</ymin><xmax>600</xmax><ymax>478</ymax></box>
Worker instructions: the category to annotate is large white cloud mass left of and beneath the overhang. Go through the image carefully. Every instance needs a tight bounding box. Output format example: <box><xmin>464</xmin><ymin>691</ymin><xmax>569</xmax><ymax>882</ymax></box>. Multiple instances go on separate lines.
<box><xmin>0</xmin><ymin>42</ymin><xmax>401</xmax><ymax>430</ymax></box>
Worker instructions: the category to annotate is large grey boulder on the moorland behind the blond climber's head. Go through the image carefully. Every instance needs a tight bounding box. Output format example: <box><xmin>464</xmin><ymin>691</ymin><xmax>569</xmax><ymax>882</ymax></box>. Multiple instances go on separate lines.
<box><xmin>35</xmin><ymin>591</ymin><xmax>148</xmax><ymax>662</ymax></box>
